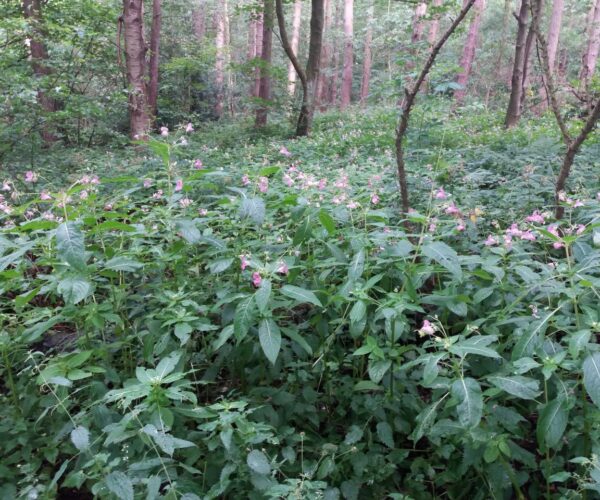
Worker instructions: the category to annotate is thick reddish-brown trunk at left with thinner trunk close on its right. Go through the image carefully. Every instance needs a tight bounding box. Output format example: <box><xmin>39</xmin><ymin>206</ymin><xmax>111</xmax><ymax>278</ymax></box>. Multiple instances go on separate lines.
<box><xmin>123</xmin><ymin>0</ymin><xmax>150</xmax><ymax>140</ymax></box>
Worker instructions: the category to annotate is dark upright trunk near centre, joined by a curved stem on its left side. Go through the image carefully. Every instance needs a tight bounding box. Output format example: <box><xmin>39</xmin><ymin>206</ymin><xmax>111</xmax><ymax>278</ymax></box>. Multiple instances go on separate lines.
<box><xmin>296</xmin><ymin>0</ymin><xmax>324</xmax><ymax>136</ymax></box>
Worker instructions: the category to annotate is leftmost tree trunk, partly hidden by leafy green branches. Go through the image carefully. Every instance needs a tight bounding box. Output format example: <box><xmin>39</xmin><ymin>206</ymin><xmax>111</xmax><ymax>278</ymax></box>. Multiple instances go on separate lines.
<box><xmin>23</xmin><ymin>0</ymin><xmax>58</xmax><ymax>145</ymax></box>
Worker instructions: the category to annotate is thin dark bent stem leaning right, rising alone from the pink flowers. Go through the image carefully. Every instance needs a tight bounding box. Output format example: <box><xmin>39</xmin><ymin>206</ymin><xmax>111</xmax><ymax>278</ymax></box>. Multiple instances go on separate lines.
<box><xmin>396</xmin><ymin>0</ymin><xmax>475</xmax><ymax>214</ymax></box>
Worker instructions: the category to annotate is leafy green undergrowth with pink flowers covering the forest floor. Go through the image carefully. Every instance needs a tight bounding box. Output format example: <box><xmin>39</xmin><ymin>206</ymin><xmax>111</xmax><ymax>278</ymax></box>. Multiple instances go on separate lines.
<box><xmin>0</xmin><ymin>107</ymin><xmax>600</xmax><ymax>500</ymax></box>
